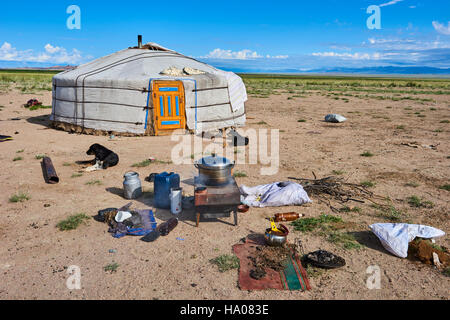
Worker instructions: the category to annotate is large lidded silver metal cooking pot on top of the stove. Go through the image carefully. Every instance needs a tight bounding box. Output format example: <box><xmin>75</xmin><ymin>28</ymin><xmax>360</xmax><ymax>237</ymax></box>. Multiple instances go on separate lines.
<box><xmin>194</xmin><ymin>154</ymin><xmax>234</xmax><ymax>186</ymax></box>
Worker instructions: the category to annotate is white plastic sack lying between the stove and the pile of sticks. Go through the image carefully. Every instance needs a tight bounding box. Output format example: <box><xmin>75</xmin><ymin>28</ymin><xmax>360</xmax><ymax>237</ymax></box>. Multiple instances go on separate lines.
<box><xmin>240</xmin><ymin>181</ymin><xmax>312</xmax><ymax>208</ymax></box>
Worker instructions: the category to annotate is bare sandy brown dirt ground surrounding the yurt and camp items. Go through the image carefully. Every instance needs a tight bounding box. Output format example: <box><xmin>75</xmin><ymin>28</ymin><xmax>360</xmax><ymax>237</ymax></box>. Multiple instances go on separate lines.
<box><xmin>0</xmin><ymin>86</ymin><xmax>450</xmax><ymax>300</ymax></box>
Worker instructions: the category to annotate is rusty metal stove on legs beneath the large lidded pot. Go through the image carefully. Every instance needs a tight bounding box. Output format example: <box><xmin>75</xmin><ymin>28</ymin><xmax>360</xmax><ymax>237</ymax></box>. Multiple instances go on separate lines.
<box><xmin>194</xmin><ymin>177</ymin><xmax>241</xmax><ymax>227</ymax></box>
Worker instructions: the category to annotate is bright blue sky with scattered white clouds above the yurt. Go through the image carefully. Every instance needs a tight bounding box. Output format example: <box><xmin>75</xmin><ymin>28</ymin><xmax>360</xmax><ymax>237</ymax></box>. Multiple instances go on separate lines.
<box><xmin>0</xmin><ymin>0</ymin><xmax>450</xmax><ymax>71</ymax></box>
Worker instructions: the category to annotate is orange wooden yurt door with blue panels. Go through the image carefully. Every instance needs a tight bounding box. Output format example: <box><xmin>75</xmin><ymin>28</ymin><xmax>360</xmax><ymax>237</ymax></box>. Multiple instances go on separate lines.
<box><xmin>153</xmin><ymin>80</ymin><xmax>186</xmax><ymax>134</ymax></box>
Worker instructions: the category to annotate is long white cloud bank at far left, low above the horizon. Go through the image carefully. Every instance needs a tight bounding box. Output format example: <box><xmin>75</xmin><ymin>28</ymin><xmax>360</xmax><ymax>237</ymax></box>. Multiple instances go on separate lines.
<box><xmin>0</xmin><ymin>42</ymin><xmax>91</xmax><ymax>64</ymax></box>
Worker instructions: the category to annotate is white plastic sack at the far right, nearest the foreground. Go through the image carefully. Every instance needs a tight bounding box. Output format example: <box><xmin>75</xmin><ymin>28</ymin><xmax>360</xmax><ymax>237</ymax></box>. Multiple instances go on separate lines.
<box><xmin>369</xmin><ymin>223</ymin><xmax>445</xmax><ymax>258</ymax></box>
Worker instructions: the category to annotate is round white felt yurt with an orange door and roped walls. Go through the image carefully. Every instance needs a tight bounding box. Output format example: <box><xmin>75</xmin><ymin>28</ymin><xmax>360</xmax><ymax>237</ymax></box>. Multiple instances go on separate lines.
<box><xmin>51</xmin><ymin>37</ymin><xmax>247</xmax><ymax>135</ymax></box>
